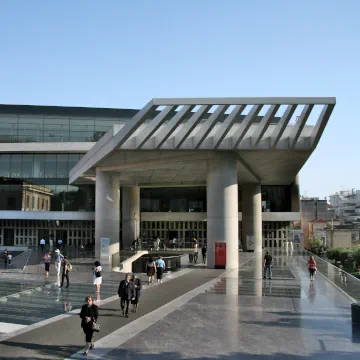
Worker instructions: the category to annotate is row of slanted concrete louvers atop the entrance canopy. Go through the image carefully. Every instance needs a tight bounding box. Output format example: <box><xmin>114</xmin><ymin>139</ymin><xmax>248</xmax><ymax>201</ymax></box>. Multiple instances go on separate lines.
<box><xmin>114</xmin><ymin>97</ymin><xmax>336</xmax><ymax>150</ymax></box>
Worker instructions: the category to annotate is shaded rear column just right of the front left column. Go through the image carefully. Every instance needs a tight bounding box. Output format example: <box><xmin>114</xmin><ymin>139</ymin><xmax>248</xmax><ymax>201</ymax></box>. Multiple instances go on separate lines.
<box><xmin>121</xmin><ymin>186</ymin><xmax>140</xmax><ymax>249</ymax></box>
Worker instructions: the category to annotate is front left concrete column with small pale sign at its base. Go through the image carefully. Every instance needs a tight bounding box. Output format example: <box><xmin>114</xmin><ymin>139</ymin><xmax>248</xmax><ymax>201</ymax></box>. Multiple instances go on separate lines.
<box><xmin>95</xmin><ymin>170</ymin><xmax>120</xmax><ymax>270</ymax></box>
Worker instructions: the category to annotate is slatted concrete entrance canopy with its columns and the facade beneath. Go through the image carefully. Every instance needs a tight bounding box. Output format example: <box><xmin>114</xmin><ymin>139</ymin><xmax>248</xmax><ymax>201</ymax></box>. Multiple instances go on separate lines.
<box><xmin>69</xmin><ymin>98</ymin><xmax>335</xmax><ymax>268</ymax></box>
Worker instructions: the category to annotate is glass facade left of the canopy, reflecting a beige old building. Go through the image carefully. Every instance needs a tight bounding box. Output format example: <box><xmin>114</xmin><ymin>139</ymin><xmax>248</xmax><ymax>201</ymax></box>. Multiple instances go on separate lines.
<box><xmin>0</xmin><ymin>153</ymin><xmax>95</xmax><ymax>211</ymax></box>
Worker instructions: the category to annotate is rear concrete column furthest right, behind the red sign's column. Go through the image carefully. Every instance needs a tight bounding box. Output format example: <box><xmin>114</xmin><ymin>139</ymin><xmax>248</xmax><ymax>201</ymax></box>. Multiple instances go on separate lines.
<box><xmin>241</xmin><ymin>183</ymin><xmax>262</xmax><ymax>252</ymax></box>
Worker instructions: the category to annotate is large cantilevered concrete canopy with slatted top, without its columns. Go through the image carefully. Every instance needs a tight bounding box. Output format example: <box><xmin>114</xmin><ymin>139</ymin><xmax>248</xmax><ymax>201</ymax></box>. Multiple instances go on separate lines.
<box><xmin>70</xmin><ymin>97</ymin><xmax>336</xmax><ymax>186</ymax></box>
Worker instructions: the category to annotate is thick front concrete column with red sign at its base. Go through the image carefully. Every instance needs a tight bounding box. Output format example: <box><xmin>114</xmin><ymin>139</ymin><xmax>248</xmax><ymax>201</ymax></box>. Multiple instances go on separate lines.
<box><xmin>206</xmin><ymin>154</ymin><xmax>239</xmax><ymax>269</ymax></box>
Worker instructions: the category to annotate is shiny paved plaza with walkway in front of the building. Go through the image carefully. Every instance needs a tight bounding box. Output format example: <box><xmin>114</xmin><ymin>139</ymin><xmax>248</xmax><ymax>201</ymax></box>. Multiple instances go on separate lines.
<box><xmin>0</xmin><ymin>251</ymin><xmax>360</xmax><ymax>360</ymax></box>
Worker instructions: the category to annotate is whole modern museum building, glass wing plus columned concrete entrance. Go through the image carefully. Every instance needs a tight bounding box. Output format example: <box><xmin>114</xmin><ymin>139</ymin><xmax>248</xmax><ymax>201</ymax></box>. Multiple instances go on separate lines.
<box><xmin>0</xmin><ymin>98</ymin><xmax>335</xmax><ymax>267</ymax></box>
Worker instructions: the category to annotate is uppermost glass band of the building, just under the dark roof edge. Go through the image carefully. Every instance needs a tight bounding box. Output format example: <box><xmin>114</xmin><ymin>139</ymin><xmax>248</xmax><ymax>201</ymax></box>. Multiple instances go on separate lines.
<box><xmin>0</xmin><ymin>114</ymin><xmax>131</xmax><ymax>143</ymax></box>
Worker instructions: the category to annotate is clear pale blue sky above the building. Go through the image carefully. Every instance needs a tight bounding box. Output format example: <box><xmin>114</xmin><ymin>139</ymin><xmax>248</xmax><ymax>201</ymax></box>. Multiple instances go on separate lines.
<box><xmin>0</xmin><ymin>0</ymin><xmax>360</xmax><ymax>198</ymax></box>
